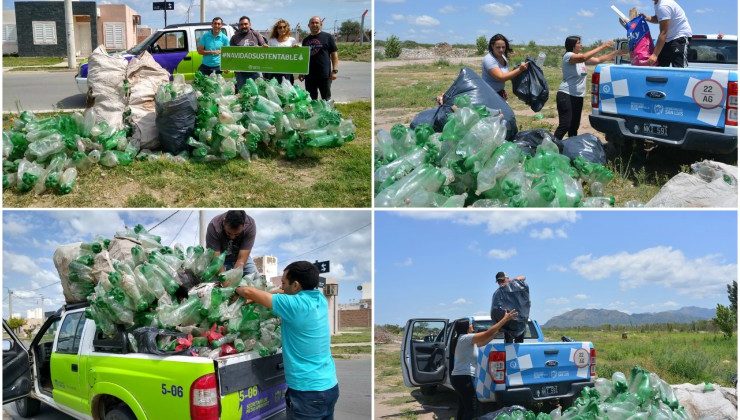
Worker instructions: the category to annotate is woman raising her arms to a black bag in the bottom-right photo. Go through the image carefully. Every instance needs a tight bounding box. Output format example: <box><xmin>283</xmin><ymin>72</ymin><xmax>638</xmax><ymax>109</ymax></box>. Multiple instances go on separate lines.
<box><xmin>450</xmin><ymin>310</ymin><xmax>517</xmax><ymax>420</ymax></box>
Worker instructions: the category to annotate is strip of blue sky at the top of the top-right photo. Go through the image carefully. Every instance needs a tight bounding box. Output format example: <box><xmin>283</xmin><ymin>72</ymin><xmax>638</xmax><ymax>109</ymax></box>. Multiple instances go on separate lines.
<box><xmin>375</xmin><ymin>0</ymin><xmax>737</xmax><ymax>45</ymax></box>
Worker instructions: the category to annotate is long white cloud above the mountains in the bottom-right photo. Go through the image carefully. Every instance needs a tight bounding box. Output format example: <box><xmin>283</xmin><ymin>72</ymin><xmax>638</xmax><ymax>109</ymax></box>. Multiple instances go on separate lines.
<box><xmin>570</xmin><ymin>246</ymin><xmax>737</xmax><ymax>298</ymax></box>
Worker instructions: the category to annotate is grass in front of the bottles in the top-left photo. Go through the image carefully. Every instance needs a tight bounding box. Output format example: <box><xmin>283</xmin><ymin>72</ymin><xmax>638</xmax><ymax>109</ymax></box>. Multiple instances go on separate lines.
<box><xmin>3</xmin><ymin>102</ymin><xmax>371</xmax><ymax>208</ymax></box>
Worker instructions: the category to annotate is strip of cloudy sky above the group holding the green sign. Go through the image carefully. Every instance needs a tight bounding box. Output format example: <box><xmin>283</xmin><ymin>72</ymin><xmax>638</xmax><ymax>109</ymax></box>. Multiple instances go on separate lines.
<box><xmin>3</xmin><ymin>0</ymin><xmax>371</xmax><ymax>30</ymax></box>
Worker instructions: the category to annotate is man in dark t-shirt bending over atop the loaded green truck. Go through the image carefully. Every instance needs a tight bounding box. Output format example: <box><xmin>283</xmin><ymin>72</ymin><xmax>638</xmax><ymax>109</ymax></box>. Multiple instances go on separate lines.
<box><xmin>206</xmin><ymin>210</ymin><xmax>257</xmax><ymax>275</ymax></box>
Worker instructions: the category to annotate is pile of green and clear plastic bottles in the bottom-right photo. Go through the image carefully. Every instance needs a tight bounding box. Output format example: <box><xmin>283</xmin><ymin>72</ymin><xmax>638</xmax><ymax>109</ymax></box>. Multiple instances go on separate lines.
<box><xmin>496</xmin><ymin>366</ymin><xmax>690</xmax><ymax>420</ymax></box>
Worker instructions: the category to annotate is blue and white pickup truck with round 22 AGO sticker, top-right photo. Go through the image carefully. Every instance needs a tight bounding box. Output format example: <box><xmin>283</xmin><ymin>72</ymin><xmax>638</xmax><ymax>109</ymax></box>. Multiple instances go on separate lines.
<box><xmin>589</xmin><ymin>35</ymin><xmax>737</xmax><ymax>154</ymax></box>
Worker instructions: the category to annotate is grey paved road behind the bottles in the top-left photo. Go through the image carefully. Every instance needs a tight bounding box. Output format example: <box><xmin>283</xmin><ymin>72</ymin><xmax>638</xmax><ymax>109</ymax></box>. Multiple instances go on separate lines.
<box><xmin>3</xmin><ymin>61</ymin><xmax>372</xmax><ymax>111</ymax></box>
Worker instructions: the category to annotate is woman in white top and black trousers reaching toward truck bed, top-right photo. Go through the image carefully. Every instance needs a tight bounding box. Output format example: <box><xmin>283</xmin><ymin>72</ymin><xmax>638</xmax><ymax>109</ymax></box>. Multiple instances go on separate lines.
<box><xmin>555</xmin><ymin>35</ymin><xmax>628</xmax><ymax>140</ymax></box>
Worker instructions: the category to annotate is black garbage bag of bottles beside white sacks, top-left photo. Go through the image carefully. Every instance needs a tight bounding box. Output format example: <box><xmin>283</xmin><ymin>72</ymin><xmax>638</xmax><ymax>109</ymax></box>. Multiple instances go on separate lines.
<box><xmin>155</xmin><ymin>91</ymin><xmax>198</xmax><ymax>155</ymax></box>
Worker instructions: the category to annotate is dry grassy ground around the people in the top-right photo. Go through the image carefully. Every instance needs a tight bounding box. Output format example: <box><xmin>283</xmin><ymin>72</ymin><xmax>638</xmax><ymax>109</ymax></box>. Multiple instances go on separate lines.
<box><xmin>375</xmin><ymin>61</ymin><xmax>737</xmax><ymax>206</ymax></box>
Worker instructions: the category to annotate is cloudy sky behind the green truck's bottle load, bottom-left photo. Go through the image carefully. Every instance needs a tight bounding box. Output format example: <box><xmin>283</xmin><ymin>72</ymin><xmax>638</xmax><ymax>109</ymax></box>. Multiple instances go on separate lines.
<box><xmin>2</xmin><ymin>209</ymin><xmax>372</xmax><ymax>317</ymax></box>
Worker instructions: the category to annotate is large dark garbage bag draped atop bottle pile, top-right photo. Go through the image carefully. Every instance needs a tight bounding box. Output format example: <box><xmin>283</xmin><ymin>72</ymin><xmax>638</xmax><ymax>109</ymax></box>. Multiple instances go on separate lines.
<box><xmin>430</xmin><ymin>67</ymin><xmax>517</xmax><ymax>140</ymax></box>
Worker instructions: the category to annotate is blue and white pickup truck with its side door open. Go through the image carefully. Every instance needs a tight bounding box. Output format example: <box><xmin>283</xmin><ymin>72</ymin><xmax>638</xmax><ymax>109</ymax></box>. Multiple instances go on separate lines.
<box><xmin>401</xmin><ymin>316</ymin><xmax>596</xmax><ymax>407</ymax></box>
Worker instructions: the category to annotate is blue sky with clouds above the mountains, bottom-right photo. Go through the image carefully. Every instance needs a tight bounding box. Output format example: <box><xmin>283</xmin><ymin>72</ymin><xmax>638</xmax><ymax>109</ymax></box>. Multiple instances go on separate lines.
<box><xmin>375</xmin><ymin>210</ymin><xmax>738</xmax><ymax>325</ymax></box>
